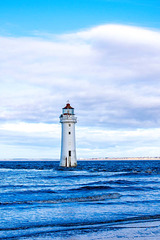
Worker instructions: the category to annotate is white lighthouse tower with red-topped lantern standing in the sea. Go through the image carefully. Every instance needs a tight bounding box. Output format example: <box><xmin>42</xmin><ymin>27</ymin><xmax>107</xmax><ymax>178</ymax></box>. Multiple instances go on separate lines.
<box><xmin>60</xmin><ymin>102</ymin><xmax>77</xmax><ymax>167</ymax></box>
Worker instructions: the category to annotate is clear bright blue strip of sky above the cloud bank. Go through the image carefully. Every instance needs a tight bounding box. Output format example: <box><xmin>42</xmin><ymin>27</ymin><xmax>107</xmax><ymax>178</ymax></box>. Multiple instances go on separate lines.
<box><xmin>0</xmin><ymin>0</ymin><xmax>160</xmax><ymax>36</ymax></box>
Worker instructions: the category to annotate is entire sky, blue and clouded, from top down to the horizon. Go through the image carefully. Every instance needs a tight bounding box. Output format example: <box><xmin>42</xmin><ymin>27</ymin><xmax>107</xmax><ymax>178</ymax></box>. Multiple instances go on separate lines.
<box><xmin>0</xmin><ymin>0</ymin><xmax>160</xmax><ymax>160</ymax></box>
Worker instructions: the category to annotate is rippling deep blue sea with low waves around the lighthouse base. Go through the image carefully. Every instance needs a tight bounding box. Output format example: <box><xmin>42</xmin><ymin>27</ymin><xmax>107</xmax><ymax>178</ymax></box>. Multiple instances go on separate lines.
<box><xmin>0</xmin><ymin>160</ymin><xmax>160</xmax><ymax>240</ymax></box>
